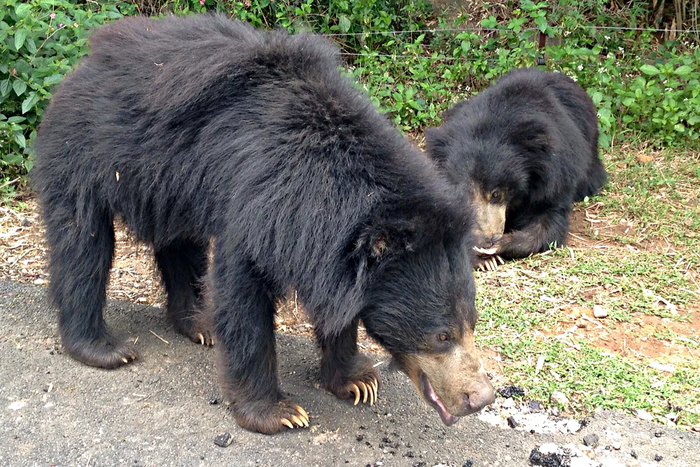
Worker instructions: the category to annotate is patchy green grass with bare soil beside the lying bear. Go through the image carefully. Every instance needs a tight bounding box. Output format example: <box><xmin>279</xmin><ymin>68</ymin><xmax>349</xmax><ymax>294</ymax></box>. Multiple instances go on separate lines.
<box><xmin>476</xmin><ymin>148</ymin><xmax>700</xmax><ymax>426</ymax></box>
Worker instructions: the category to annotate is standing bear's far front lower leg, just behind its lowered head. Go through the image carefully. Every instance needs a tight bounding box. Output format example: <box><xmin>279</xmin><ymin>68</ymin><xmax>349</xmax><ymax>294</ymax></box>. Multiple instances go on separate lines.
<box><xmin>317</xmin><ymin>320</ymin><xmax>379</xmax><ymax>405</ymax></box>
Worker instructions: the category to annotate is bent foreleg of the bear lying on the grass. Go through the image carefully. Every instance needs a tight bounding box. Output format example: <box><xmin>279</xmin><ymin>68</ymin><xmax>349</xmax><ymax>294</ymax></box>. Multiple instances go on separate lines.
<box><xmin>496</xmin><ymin>207</ymin><xmax>571</xmax><ymax>258</ymax></box>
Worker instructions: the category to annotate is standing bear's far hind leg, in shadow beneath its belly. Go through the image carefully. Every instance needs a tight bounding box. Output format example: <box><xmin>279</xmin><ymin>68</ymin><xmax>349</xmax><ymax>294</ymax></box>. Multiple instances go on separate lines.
<box><xmin>155</xmin><ymin>240</ymin><xmax>214</xmax><ymax>345</ymax></box>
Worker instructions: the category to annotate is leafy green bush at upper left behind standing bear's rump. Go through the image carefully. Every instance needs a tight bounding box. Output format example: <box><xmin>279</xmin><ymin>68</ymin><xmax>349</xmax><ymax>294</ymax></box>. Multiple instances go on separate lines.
<box><xmin>0</xmin><ymin>0</ymin><xmax>122</xmax><ymax>195</ymax></box>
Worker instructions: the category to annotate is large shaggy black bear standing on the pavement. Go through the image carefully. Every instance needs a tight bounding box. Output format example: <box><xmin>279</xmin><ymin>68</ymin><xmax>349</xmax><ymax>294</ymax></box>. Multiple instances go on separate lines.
<box><xmin>33</xmin><ymin>16</ymin><xmax>494</xmax><ymax>433</ymax></box>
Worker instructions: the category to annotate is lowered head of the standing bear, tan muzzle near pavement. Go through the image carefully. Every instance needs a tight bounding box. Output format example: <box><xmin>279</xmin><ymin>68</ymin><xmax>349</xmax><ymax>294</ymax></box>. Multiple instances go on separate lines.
<box><xmin>358</xmin><ymin>199</ymin><xmax>495</xmax><ymax>425</ymax></box>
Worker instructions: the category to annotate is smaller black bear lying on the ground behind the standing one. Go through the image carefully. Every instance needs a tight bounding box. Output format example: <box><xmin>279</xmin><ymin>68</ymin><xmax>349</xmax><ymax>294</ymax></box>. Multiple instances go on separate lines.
<box><xmin>426</xmin><ymin>69</ymin><xmax>607</xmax><ymax>269</ymax></box>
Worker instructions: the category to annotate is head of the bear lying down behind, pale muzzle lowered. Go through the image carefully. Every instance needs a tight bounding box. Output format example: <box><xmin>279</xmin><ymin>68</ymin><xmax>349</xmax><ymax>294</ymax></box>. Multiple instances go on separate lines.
<box><xmin>426</xmin><ymin>119</ymin><xmax>551</xmax><ymax>249</ymax></box>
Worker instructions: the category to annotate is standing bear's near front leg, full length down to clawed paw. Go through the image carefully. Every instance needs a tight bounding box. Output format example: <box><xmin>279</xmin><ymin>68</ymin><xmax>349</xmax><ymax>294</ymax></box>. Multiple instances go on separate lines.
<box><xmin>213</xmin><ymin>256</ymin><xmax>309</xmax><ymax>434</ymax></box>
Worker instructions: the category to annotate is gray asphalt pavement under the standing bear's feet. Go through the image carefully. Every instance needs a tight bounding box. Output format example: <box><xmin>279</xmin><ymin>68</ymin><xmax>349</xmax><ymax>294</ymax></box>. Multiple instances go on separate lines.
<box><xmin>0</xmin><ymin>281</ymin><xmax>700</xmax><ymax>467</ymax></box>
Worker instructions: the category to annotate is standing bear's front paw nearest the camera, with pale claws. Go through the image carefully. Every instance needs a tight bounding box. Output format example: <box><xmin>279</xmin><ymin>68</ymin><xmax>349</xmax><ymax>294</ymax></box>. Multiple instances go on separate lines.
<box><xmin>233</xmin><ymin>399</ymin><xmax>309</xmax><ymax>435</ymax></box>
